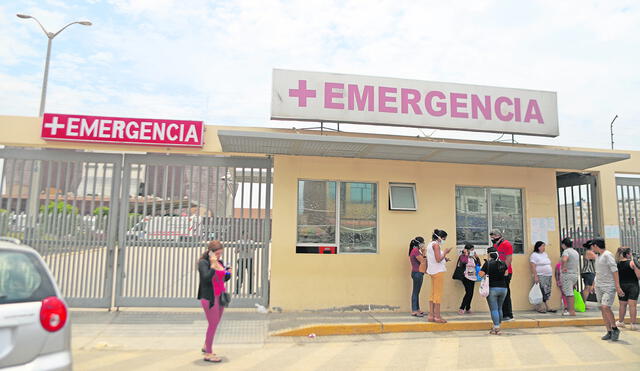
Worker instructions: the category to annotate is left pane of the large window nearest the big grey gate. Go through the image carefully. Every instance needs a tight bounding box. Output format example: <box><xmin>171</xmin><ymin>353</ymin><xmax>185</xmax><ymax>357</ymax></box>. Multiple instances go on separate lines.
<box><xmin>298</xmin><ymin>180</ymin><xmax>336</xmax><ymax>244</ymax></box>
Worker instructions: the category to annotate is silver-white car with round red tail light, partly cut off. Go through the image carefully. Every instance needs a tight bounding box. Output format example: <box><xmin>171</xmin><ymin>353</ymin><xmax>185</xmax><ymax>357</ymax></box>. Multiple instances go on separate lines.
<box><xmin>0</xmin><ymin>238</ymin><xmax>72</xmax><ymax>370</ymax></box>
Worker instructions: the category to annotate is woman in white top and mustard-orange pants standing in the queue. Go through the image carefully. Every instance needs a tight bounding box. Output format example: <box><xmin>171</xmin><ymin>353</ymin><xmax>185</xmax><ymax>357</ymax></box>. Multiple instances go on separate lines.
<box><xmin>427</xmin><ymin>229</ymin><xmax>451</xmax><ymax>323</ymax></box>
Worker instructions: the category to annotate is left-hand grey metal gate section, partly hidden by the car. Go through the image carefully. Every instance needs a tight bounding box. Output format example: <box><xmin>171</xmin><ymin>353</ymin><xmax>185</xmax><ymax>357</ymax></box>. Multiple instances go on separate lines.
<box><xmin>0</xmin><ymin>148</ymin><xmax>122</xmax><ymax>307</ymax></box>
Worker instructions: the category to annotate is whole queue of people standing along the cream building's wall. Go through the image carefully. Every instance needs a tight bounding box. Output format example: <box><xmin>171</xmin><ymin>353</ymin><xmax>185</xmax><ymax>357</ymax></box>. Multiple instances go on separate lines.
<box><xmin>409</xmin><ymin>229</ymin><xmax>640</xmax><ymax>341</ymax></box>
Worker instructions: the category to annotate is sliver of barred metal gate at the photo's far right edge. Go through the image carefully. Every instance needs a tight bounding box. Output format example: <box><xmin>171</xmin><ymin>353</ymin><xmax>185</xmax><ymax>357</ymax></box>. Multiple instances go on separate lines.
<box><xmin>616</xmin><ymin>177</ymin><xmax>640</xmax><ymax>254</ymax></box>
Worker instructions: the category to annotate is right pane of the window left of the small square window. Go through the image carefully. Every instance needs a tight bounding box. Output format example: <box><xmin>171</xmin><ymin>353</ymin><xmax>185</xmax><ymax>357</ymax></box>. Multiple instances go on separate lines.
<box><xmin>339</xmin><ymin>183</ymin><xmax>378</xmax><ymax>253</ymax></box>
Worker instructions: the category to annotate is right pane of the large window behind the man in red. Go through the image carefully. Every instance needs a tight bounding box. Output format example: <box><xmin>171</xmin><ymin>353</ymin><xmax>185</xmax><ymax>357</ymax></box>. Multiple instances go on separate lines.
<box><xmin>491</xmin><ymin>188</ymin><xmax>524</xmax><ymax>254</ymax></box>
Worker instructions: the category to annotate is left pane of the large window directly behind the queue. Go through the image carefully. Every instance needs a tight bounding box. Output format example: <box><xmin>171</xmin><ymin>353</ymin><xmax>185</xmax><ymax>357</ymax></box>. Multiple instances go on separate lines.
<box><xmin>456</xmin><ymin>187</ymin><xmax>489</xmax><ymax>246</ymax></box>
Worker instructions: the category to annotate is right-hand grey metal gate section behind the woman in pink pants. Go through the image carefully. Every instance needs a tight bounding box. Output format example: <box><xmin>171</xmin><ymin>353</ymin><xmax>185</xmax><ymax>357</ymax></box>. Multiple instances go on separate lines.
<box><xmin>115</xmin><ymin>155</ymin><xmax>272</xmax><ymax>307</ymax></box>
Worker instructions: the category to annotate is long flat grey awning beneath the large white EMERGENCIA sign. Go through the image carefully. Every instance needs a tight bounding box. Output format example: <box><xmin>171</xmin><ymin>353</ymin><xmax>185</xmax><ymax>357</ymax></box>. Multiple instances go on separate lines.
<box><xmin>218</xmin><ymin>130</ymin><xmax>630</xmax><ymax>170</ymax></box>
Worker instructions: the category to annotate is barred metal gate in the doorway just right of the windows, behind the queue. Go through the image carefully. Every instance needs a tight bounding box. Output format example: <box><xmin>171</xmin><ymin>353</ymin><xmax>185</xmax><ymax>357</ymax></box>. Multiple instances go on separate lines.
<box><xmin>556</xmin><ymin>173</ymin><xmax>600</xmax><ymax>292</ymax></box>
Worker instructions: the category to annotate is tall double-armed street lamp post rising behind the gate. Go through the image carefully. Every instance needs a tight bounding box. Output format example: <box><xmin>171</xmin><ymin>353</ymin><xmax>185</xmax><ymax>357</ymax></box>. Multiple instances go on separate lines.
<box><xmin>16</xmin><ymin>14</ymin><xmax>91</xmax><ymax>240</ymax></box>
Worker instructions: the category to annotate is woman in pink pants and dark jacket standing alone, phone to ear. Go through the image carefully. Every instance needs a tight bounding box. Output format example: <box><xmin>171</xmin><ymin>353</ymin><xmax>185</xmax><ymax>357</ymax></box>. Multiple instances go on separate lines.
<box><xmin>198</xmin><ymin>241</ymin><xmax>231</xmax><ymax>362</ymax></box>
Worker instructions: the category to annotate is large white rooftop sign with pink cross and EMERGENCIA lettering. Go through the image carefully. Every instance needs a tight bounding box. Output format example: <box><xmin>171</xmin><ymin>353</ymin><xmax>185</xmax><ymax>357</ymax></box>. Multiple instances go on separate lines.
<box><xmin>271</xmin><ymin>69</ymin><xmax>559</xmax><ymax>137</ymax></box>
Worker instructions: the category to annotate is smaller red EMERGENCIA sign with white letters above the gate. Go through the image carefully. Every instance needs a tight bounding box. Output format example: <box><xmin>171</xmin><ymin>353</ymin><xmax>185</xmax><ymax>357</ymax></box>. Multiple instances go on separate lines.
<box><xmin>41</xmin><ymin>113</ymin><xmax>204</xmax><ymax>147</ymax></box>
